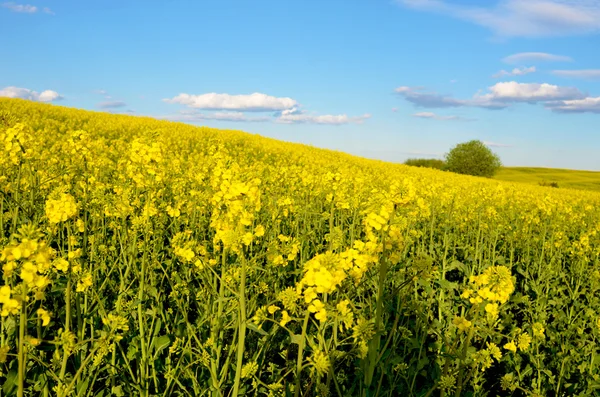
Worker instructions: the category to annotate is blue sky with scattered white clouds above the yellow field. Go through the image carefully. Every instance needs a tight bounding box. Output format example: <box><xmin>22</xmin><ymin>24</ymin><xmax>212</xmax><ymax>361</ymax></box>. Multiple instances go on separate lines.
<box><xmin>0</xmin><ymin>0</ymin><xmax>600</xmax><ymax>170</ymax></box>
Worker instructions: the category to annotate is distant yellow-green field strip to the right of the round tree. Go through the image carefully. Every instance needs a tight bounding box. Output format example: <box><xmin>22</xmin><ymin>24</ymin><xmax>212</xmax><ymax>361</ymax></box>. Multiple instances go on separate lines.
<box><xmin>495</xmin><ymin>167</ymin><xmax>600</xmax><ymax>191</ymax></box>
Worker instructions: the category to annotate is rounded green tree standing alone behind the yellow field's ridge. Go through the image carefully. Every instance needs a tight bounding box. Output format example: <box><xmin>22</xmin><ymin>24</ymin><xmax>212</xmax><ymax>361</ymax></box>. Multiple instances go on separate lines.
<box><xmin>445</xmin><ymin>140</ymin><xmax>502</xmax><ymax>178</ymax></box>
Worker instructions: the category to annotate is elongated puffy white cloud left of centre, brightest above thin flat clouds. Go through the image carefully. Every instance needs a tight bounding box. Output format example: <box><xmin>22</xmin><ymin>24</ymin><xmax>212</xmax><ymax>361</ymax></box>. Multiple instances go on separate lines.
<box><xmin>163</xmin><ymin>92</ymin><xmax>298</xmax><ymax>112</ymax></box>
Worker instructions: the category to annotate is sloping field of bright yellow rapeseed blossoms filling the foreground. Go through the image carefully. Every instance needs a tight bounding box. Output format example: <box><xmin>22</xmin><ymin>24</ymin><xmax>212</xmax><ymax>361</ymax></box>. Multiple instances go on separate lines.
<box><xmin>0</xmin><ymin>98</ymin><xmax>600</xmax><ymax>397</ymax></box>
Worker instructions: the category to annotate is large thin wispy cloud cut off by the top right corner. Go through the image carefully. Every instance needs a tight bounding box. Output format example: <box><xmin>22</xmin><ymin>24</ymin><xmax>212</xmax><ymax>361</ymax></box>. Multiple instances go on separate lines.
<box><xmin>396</xmin><ymin>0</ymin><xmax>600</xmax><ymax>37</ymax></box>
